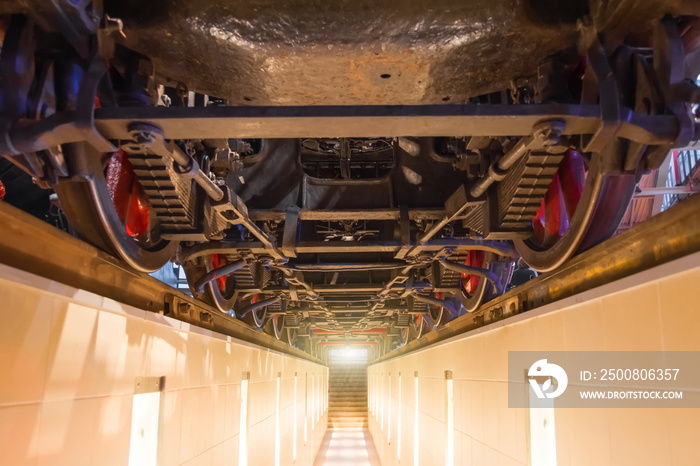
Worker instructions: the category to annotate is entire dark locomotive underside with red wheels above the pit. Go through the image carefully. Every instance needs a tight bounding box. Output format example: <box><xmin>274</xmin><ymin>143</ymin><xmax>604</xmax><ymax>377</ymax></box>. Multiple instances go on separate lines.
<box><xmin>0</xmin><ymin>0</ymin><xmax>700</xmax><ymax>351</ymax></box>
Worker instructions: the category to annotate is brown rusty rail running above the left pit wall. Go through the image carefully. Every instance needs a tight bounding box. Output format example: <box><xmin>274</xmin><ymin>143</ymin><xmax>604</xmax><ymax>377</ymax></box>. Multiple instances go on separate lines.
<box><xmin>0</xmin><ymin>202</ymin><xmax>322</xmax><ymax>364</ymax></box>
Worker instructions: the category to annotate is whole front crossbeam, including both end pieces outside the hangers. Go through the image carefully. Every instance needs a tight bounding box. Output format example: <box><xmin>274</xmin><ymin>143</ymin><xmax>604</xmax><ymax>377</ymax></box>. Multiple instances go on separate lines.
<box><xmin>8</xmin><ymin>103</ymin><xmax>680</xmax><ymax>153</ymax></box>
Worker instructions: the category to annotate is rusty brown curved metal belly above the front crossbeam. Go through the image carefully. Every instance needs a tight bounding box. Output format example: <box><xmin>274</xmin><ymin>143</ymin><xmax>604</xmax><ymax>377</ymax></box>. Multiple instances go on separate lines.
<box><xmin>105</xmin><ymin>0</ymin><xmax>588</xmax><ymax>105</ymax></box>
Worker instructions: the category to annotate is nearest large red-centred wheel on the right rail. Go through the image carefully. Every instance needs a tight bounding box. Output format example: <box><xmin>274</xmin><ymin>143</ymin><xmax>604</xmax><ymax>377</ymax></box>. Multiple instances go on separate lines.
<box><xmin>515</xmin><ymin>150</ymin><xmax>636</xmax><ymax>272</ymax></box>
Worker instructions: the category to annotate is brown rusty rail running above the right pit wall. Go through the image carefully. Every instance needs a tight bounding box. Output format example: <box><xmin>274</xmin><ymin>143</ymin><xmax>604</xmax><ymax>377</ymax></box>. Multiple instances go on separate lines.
<box><xmin>374</xmin><ymin>196</ymin><xmax>700</xmax><ymax>362</ymax></box>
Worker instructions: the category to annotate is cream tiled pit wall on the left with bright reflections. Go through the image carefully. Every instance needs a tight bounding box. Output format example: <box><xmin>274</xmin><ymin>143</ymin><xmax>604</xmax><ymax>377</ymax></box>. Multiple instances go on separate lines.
<box><xmin>0</xmin><ymin>265</ymin><xmax>328</xmax><ymax>466</ymax></box>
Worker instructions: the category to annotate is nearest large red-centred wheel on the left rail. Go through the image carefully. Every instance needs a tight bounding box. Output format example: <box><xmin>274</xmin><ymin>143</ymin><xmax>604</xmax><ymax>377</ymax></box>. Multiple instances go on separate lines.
<box><xmin>55</xmin><ymin>143</ymin><xmax>177</xmax><ymax>272</ymax></box>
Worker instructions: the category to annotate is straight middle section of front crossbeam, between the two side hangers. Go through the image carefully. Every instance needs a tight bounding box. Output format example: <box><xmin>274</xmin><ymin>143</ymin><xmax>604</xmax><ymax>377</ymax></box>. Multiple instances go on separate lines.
<box><xmin>95</xmin><ymin>104</ymin><xmax>600</xmax><ymax>139</ymax></box>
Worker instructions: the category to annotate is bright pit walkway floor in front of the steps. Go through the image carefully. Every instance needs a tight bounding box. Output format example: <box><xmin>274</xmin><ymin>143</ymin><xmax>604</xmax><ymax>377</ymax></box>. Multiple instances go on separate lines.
<box><xmin>314</xmin><ymin>428</ymin><xmax>381</xmax><ymax>466</ymax></box>
